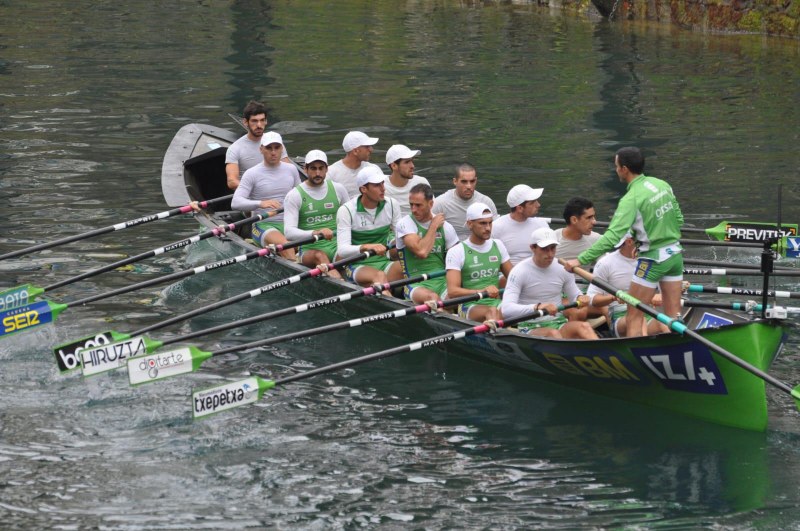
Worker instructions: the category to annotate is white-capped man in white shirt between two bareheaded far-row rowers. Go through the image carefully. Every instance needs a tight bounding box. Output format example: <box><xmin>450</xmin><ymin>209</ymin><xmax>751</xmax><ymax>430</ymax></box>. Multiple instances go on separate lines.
<box><xmin>492</xmin><ymin>184</ymin><xmax>550</xmax><ymax>265</ymax></box>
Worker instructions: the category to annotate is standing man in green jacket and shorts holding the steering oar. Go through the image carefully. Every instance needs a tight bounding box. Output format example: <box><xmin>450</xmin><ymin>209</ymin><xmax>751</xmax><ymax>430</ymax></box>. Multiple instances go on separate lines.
<box><xmin>567</xmin><ymin>147</ymin><xmax>683</xmax><ymax>337</ymax></box>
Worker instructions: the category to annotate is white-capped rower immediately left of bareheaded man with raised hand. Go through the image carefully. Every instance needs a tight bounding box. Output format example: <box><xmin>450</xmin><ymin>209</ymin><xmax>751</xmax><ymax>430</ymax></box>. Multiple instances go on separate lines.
<box><xmin>336</xmin><ymin>164</ymin><xmax>403</xmax><ymax>286</ymax></box>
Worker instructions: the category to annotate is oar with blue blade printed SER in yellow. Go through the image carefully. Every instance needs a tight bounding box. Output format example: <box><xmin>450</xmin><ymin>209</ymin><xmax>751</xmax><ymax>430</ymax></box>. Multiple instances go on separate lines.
<box><xmin>0</xmin><ymin>235</ymin><xmax>322</xmax><ymax>337</ymax></box>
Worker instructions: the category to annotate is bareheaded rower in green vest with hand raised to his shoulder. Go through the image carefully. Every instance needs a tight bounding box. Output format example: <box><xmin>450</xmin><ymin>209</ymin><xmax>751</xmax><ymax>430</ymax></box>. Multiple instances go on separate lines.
<box><xmin>395</xmin><ymin>183</ymin><xmax>458</xmax><ymax>304</ymax></box>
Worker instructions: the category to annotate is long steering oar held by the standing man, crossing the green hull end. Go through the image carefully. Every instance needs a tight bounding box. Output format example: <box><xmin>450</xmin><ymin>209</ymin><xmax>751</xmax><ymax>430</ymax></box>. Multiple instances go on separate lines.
<box><xmin>559</xmin><ymin>260</ymin><xmax>800</xmax><ymax>409</ymax></box>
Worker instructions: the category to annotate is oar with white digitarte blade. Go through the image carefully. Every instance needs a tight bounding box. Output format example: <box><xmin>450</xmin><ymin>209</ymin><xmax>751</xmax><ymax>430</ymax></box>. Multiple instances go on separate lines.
<box><xmin>128</xmin><ymin>276</ymin><xmax>478</xmax><ymax>385</ymax></box>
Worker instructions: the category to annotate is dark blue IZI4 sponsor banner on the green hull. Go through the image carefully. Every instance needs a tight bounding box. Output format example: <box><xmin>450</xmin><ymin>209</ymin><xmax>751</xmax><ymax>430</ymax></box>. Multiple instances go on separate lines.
<box><xmin>631</xmin><ymin>343</ymin><xmax>728</xmax><ymax>395</ymax></box>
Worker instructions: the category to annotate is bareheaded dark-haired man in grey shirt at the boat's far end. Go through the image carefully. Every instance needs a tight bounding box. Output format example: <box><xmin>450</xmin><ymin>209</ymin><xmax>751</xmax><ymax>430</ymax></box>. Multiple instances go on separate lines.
<box><xmin>225</xmin><ymin>100</ymin><xmax>291</xmax><ymax>190</ymax></box>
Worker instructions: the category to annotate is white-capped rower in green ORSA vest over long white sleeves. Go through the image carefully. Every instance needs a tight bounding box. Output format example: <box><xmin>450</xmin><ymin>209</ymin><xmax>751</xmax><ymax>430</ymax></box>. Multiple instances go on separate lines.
<box><xmin>283</xmin><ymin>149</ymin><xmax>350</xmax><ymax>278</ymax></box>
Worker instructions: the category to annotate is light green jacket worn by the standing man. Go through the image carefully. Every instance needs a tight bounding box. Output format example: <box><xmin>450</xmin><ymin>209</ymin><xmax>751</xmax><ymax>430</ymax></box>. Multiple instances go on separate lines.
<box><xmin>578</xmin><ymin>174</ymin><xmax>683</xmax><ymax>265</ymax></box>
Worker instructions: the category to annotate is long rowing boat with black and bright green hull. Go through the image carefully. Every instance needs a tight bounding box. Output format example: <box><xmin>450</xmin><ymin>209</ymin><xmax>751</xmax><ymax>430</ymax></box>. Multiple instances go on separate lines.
<box><xmin>161</xmin><ymin>124</ymin><xmax>786</xmax><ymax>431</ymax></box>
